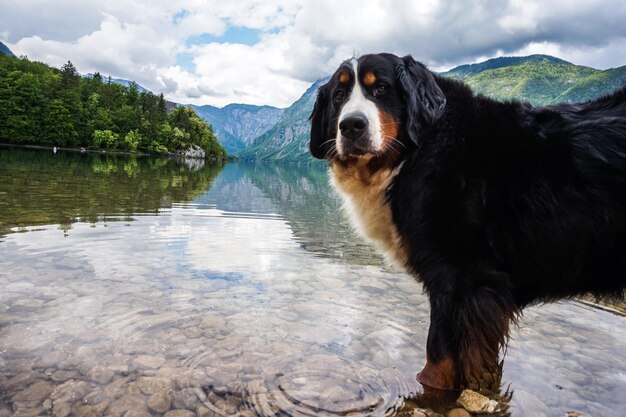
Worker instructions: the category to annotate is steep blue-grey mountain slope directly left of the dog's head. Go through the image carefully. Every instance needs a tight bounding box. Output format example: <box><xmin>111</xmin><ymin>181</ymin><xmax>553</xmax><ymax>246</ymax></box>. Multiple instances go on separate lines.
<box><xmin>239</xmin><ymin>78</ymin><xmax>328</xmax><ymax>161</ymax></box>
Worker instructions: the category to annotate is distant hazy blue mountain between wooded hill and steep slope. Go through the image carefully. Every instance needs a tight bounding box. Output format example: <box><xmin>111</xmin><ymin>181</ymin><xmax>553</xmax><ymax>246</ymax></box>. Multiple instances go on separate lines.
<box><xmin>191</xmin><ymin>104</ymin><xmax>285</xmax><ymax>155</ymax></box>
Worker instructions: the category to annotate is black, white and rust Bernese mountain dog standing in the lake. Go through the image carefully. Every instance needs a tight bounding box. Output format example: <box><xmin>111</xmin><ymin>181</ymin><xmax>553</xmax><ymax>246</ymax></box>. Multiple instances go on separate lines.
<box><xmin>310</xmin><ymin>54</ymin><xmax>626</xmax><ymax>389</ymax></box>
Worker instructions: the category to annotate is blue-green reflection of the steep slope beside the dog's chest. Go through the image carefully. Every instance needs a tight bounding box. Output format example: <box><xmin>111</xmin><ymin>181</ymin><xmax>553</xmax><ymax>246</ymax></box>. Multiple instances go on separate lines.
<box><xmin>240</xmin><ymin>163</ymin><xmax>382</xmax><ymax>265</ymax></box>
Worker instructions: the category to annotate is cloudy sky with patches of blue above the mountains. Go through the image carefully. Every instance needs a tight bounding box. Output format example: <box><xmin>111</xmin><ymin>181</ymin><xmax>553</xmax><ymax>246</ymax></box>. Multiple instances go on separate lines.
<box><xmin>0</xmin><ymin>0</ymin><xmax>626</xmax><ymax>107</ymax></box>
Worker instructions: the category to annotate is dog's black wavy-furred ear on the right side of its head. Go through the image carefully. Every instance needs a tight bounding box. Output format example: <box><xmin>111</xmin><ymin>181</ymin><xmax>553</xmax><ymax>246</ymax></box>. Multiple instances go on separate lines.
<box><xmin>396</xmin><ymin>55</ymin><xmax>446</xmax><ymax>146</ymax></box>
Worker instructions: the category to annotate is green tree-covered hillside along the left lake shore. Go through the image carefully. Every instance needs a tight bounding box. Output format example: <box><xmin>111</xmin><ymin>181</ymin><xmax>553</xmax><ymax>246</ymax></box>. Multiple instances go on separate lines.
<box><xmin>0</xmin><ymin>54</ymin><xmax>226</xmax><ymax>158</ymax></box>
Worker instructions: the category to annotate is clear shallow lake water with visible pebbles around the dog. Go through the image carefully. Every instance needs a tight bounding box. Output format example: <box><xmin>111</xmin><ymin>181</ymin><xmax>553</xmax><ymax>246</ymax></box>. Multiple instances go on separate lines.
<box><xmin>0</xmin><ymin>147</ymin><xmax>626</xmax><ymax>417</ymax></box>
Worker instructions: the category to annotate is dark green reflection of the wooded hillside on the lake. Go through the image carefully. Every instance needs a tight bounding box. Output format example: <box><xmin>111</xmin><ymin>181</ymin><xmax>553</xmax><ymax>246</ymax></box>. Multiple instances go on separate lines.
<box><xmin>0</xmin><ymin>148</ymin><xmax>223</xmax><ymax>232</ymax></box>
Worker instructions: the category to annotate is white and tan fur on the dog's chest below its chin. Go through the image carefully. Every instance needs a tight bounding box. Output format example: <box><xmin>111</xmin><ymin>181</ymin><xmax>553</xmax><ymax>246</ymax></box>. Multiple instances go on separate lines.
<box><xmin>330</xmin><ymin>158</ymin><xmax>408</xmax><ymax>268</ymax></box>
